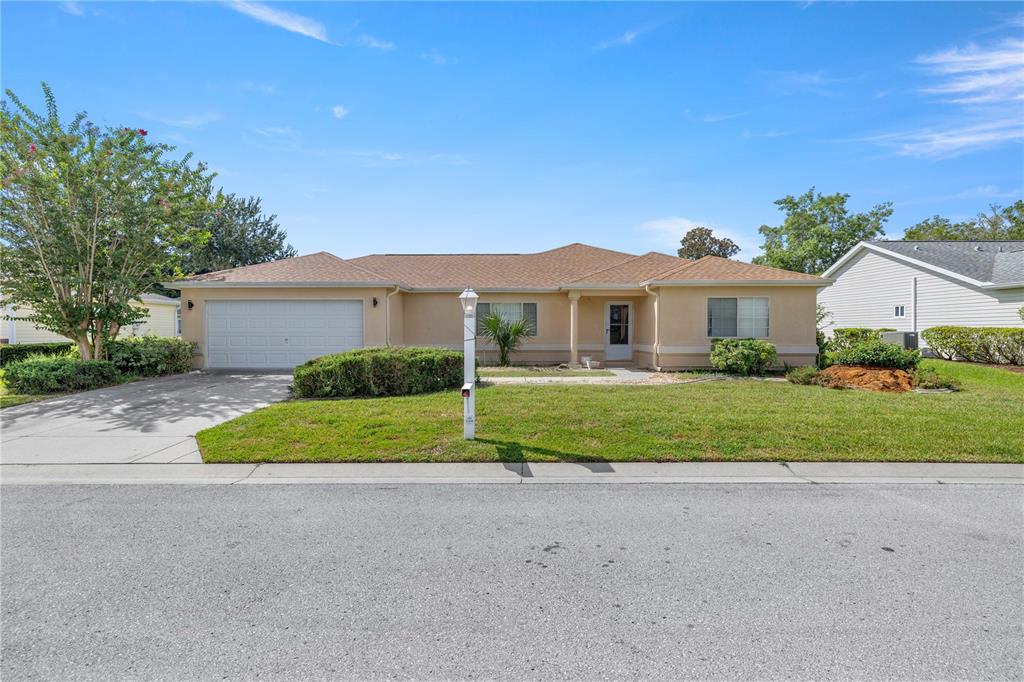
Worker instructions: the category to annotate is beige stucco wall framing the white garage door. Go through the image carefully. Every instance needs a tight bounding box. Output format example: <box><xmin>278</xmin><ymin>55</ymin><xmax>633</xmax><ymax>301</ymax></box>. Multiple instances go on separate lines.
<box><xmin>181</xmin><ymin>287</ymin><xmax>389</xmax><ymax>368</ymax></box>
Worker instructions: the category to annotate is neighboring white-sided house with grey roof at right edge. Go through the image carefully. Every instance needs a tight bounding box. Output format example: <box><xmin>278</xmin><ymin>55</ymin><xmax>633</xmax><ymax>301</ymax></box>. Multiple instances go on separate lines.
<box><xmin>818</xmin><ymin>241</ymin><xmax>1024</xmax><ymax>345</ymax></box>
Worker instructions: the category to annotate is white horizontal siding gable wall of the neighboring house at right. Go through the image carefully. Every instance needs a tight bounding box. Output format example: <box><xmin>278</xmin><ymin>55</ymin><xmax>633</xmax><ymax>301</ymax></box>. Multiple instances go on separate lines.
<box><xmin>818</xmin><ymin>249</ymin><xmax>1024</xmax><ymax>333</ymax></box>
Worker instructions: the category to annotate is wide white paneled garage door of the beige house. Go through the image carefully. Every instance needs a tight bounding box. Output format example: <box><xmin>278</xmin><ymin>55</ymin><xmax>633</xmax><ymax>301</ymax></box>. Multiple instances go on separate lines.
<box><xmin>206</xmin><ymin>301</ymin><xmax>362</xmax><ymax>369</ymax></box>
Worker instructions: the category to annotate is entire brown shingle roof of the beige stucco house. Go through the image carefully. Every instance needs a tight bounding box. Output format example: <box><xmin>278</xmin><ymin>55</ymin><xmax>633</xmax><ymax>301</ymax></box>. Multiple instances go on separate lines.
<box><xmin>169</xmin><ymin>244</ymin><xmax>826</xmax><ymax>291</ymax></box>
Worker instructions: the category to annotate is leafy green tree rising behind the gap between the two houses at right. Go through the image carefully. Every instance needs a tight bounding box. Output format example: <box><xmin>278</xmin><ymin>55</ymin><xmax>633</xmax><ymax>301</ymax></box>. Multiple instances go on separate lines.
<box><xmin>753</xmin><ymin>187</ymin><xmax>893</xmax><ymax>274</ymax></box>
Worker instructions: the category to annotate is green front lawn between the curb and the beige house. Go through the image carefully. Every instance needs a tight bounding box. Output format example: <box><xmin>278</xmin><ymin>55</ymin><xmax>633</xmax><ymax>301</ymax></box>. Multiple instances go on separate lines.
<box><xmin>197</xmin><ymin>360</ymin><xmax>1024</xmax><ymax>462</ymax></box>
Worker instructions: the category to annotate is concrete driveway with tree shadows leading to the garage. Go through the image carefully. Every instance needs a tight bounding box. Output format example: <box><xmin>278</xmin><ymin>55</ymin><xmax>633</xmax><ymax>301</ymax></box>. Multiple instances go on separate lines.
<box><xmin>0</xmin><ymin>373</ymin><xmax>292</xmax><ymax>464</ymax></box>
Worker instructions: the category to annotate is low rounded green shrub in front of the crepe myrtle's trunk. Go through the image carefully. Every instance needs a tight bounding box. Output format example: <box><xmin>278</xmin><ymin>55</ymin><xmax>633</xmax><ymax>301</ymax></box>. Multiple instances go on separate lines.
<box><xmin>4</xmin><ymin>355</ymin><xmax>121</xmax><ymax>394</ymax></box>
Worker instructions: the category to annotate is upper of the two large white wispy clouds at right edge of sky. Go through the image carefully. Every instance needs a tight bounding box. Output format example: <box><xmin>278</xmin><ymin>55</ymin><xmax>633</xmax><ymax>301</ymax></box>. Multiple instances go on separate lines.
<box><xmin>916</xmin><ymin>39</ymin><xmax>1024</xmax><ymax>104</ymax></box>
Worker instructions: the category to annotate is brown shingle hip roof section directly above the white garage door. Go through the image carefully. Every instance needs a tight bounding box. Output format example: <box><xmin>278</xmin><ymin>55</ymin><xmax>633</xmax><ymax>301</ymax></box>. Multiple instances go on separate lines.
<box><xmin>178</xmin><ymin>251</ymin><xmax>390</xmax><ymax>284</ymax></box>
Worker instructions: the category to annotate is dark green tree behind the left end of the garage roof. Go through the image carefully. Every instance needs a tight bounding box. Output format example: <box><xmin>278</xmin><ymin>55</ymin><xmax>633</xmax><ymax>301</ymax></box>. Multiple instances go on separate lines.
<box><xmin>181</xmin><ymin>195</ymin><xmax>298</xmax><ymax>274</ymax></box>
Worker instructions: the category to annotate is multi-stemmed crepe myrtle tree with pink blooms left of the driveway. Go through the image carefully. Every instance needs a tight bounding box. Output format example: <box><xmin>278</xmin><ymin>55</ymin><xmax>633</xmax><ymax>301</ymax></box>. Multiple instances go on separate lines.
<box><xmin>0</xmin><ymin>83</ymin><xmax>213</xmax><ymax>359</ymax></box>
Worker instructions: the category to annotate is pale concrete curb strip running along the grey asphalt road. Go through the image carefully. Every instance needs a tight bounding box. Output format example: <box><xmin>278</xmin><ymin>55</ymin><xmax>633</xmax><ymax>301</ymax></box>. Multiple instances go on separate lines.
<box><xmin>0</xmin><ymin>462</ymin><xmax>1024</xmax><ymax>485</ymax></box>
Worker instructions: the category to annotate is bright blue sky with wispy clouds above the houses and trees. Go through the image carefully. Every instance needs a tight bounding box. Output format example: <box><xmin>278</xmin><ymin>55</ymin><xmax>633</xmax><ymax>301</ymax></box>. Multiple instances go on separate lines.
<box><xmin>6</xmin><ymin>2</ymin><xmax>1024</xmax><ymax>259</ymax></box>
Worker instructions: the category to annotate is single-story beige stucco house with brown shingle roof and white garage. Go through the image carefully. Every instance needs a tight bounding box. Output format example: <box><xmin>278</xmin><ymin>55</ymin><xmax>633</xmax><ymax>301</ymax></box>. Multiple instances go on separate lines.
<box><xmin>167</xmin><ymin>244</ymin><xmax>829</xmax><ymax>370</ymax></box>
